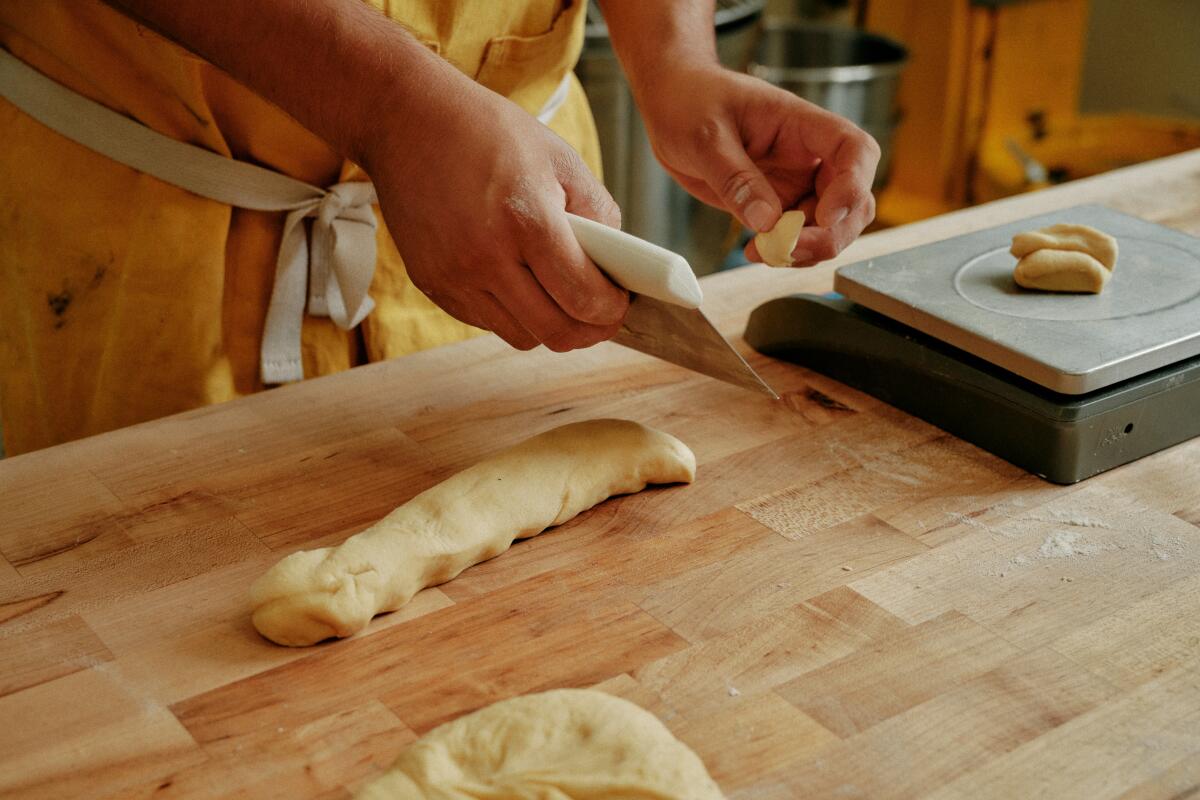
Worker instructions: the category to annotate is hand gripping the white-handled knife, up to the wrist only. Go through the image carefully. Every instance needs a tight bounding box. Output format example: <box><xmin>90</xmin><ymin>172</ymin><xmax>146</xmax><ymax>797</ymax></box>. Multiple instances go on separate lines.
<box><xmin>362</xmin><ymin>76</ymin><xmax>629</xmax><ymax>351</ymax></box>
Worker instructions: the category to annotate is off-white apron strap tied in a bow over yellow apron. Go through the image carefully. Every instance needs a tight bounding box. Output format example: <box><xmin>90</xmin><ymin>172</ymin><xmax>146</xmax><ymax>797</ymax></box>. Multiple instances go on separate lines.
<box><xmin>0</xmin><ymin>48</ymin><xmax>571</xmax><ymax>384</ymax></box>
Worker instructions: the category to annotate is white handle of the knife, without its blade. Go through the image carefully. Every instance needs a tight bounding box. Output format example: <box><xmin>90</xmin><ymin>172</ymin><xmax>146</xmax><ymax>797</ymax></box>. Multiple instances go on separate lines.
<box><xmin>566</xmin><ymin>213</ymin><xmax>704</xmax><ymax>308</ymax></box>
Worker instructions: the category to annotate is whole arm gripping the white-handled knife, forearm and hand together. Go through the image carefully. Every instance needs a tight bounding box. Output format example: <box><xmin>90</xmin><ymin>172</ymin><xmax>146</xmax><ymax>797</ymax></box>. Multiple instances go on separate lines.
<box><xmin>108</xmin><ymin>0</ymin><xmax>629</xmax><ymax>350</ymax></box>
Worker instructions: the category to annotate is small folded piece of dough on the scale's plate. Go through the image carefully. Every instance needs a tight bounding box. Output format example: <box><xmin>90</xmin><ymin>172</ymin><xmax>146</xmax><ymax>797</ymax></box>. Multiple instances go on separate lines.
<box><xmin>1009</xmin><ymin>224</ymin><xmax>1117</xmax><ymax>294</ymax></box>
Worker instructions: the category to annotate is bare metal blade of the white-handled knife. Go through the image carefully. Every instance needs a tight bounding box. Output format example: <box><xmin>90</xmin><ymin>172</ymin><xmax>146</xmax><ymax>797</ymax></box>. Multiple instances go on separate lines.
<box><xmin>612</xmin><ymin>294</ymin><xmax>779</xmax><ymax>399</ymax></box>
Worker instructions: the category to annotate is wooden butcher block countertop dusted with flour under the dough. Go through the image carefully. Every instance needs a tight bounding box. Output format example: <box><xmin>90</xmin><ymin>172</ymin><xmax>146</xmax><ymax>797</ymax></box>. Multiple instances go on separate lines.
<box><xmin>0</xmin><ymin>151</ymin><xmax>1200</xmax><ymax>800</ymax></box>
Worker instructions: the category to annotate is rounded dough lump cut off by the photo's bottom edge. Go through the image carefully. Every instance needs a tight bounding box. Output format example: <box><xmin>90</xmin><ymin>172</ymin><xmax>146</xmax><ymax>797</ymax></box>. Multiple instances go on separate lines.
<box><xmin>355</xmin><ymin>688</ymin><xmax>725</xmax><ymax>800</ymax></box>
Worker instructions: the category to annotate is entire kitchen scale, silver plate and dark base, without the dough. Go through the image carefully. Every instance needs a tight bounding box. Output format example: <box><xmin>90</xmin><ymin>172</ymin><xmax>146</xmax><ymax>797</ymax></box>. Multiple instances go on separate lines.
<box><xmin>745</xmin><ymin>206</ymin><xmax>1200</xmax><ymax>483</ymax></box>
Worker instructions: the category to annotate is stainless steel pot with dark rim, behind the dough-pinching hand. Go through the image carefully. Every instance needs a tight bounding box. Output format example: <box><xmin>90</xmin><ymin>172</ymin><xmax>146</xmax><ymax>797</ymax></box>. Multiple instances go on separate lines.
<box><xmin>750</xmin><ymin>22</ymin><xmax>908</xmax><ymax>188</ymax></box>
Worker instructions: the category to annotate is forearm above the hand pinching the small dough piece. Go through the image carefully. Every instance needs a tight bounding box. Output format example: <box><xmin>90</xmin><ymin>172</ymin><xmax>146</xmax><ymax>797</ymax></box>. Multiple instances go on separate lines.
<box><xmin>598</xmin><ymin>0</ymin><xmax>719</xmax><ymax>98</ymax></box>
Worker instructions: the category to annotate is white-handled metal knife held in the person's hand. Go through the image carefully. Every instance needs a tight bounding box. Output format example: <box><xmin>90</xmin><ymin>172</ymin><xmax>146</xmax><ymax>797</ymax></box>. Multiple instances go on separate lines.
<box><xmin>566</xmin><ymin>213</ymin><xmax>779</xmax><ymax>399</ymax></box>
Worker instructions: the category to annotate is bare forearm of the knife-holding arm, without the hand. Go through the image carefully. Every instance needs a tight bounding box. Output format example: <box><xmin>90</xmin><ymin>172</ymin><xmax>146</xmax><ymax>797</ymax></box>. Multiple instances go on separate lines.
<box><xmin>106</xmin><ymin>0</ymin><xmax>469</xmax><ymax>170</ymax></box>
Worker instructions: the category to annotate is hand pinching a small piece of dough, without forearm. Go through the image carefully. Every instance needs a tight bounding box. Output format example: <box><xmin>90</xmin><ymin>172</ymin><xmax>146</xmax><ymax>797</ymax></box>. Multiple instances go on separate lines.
<box><xmin>637</xmin><ymin>65</ymin><xmax>880</xmax><ymax>266</ymax></box>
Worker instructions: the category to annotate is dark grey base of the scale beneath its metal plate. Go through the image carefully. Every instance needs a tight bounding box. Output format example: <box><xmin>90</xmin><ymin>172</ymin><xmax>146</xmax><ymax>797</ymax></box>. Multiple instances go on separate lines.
<box><xmin>745</xmin><ymin>294</ymin><xmax>1200</xmax><ymax>483</ymax></box>
